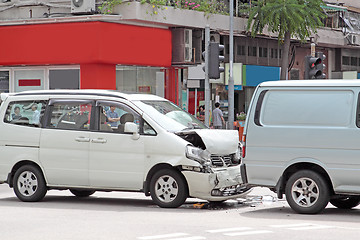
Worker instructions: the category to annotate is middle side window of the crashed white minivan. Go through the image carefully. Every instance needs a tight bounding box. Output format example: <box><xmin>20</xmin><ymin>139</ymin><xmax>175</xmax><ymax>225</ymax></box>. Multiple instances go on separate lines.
<box><xmin>47</xmin><ymin>101</ymin><xmax>92</xmax><ymax>130</ymax></box>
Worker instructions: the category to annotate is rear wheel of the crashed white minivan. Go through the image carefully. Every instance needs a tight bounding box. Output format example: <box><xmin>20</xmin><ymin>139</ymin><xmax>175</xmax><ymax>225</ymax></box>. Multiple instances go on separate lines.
<box><xmin>13</xmin><ymin>165</ymin><xmax>47</xmax><ymax>202</ymax></box>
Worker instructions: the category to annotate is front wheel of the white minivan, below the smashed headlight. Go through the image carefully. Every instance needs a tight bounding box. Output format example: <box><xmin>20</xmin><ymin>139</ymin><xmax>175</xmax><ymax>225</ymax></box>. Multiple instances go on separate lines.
<box><xmin>150</xmin><ymin>169</ymin><xmax>189</xmax><ymax>208</ymax></box>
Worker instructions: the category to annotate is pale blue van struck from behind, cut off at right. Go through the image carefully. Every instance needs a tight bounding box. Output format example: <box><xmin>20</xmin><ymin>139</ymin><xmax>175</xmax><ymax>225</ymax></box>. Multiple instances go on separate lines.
<box><xmin>241</xmin><ymin>80</ymin><xmax>360</xmax><ymax>214</ymax></box>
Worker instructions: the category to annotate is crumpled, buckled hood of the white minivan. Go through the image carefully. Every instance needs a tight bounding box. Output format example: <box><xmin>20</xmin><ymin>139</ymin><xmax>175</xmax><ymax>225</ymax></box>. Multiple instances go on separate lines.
<box><xmin>176</xmin><ymin>129</ymin><xmax>239</xmax><ymax>155</ymax></box>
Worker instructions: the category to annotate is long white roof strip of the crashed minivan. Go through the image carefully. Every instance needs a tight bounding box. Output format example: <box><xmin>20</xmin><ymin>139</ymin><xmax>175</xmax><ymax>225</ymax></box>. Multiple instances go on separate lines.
<box><xmin>13</xmin><ymin>89</ymin><xmax>165</xmax><ymax>100</ymax></box>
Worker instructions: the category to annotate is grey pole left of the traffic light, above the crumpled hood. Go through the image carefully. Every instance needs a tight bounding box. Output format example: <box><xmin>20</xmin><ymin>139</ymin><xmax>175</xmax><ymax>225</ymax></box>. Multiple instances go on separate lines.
<box><xmin>205</xmin><ymin>25</ymin><xmax>211</xmax><ymax>126</ymax></box>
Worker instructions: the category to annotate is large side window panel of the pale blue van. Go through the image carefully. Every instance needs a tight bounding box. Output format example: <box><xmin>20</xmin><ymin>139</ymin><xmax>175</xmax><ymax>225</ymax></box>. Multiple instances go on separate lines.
<box><xmin>260</xmin><ymin>90</ymin><xmax>354</xmax><ymax>127</ymax></box>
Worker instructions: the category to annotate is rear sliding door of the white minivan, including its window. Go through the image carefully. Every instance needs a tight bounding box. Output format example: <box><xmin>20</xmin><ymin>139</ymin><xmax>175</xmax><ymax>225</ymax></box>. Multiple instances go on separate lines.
<box><xmin>40</xmin><ymin>99</ymin><xmax>93</xmax><ymax>186</ymax></box>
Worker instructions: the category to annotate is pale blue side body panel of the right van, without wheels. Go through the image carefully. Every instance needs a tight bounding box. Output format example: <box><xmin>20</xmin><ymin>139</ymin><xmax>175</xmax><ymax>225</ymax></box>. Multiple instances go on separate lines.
<box><xmin>244</xmin><ymin>87</ymin><xmax>360</xmax><ymax>193</ymax></box>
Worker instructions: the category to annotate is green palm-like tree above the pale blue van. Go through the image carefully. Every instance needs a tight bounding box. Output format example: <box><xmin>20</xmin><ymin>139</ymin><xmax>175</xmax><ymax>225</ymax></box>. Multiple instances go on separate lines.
<box><xmin>245</xmin><ymin>0</ymin><xmax>325</xmax><ymax>80</ymax></box>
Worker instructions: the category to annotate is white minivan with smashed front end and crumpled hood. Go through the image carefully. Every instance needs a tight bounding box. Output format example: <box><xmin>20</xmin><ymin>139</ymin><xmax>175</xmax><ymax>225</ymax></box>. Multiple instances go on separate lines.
<box><xmin>0</xmin><ymin>90</ymin><xmax>248</xmax><ymax>207</ymax></box>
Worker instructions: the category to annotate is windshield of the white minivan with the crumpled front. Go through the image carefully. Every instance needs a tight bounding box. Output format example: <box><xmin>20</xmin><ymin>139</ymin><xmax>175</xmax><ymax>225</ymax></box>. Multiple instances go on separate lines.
<box><xmin>134</xmin><ymin>100</ymin><xmax>207</xmax><ymax>132</ymax></box>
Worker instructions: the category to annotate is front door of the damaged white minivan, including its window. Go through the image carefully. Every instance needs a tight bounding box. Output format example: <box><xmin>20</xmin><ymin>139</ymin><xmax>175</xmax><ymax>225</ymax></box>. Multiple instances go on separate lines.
<box><xmin>89</xmin><ymin>101</ymin><xmax>145</xmax><ymax>190</ymax></box>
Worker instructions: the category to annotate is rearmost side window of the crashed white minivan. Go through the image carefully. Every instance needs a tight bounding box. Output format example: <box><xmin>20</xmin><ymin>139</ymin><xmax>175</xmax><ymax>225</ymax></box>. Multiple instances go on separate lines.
<box><xmin>4</xmin><ymin>100</ymin><xmax>46</xmax><ymax>127</ymax></box>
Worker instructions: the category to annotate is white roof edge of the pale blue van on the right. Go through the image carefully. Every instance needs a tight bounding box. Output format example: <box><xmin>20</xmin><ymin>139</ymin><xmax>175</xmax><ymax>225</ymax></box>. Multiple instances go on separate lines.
<box><xmin>259</xmin><ymin>79</ymin><xmax>360</xmax><ymax>87</ymax></box>
